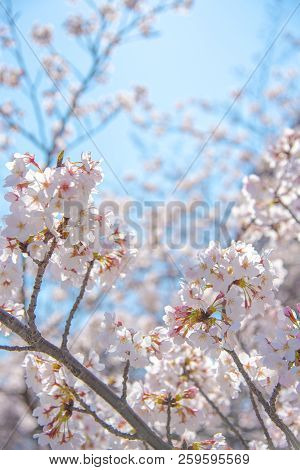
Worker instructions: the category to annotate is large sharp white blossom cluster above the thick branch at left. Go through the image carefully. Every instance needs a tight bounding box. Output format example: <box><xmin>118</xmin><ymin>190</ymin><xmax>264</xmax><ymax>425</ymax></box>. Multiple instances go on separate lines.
<box><xmin>0</xmin><ymin>153</ymin><xmax>135</xmax><ymax>332</ymax></box>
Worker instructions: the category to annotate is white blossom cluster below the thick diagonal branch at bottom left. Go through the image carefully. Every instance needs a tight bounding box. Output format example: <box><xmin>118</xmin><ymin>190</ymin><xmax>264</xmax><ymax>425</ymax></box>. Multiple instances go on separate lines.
<box><xmin>24</xmin><ymin>351</ymin><xmax>104</xmax><ymax>449</ymax></box>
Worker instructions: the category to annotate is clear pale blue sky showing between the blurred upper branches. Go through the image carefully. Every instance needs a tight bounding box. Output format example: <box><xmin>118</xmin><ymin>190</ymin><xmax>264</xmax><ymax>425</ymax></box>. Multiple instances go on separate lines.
<box><xmin>4</xmin><ymin>0</ymin><xmax>300</xmax><ymax>195</ymax></box>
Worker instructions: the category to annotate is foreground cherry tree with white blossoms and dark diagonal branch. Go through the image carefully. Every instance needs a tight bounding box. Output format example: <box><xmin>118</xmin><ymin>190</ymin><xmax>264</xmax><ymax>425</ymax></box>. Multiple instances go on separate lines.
<box><xmin>0</xmin><ymin>136</ymin><xmax>300</xmax><ymax>449</ymax></box>
